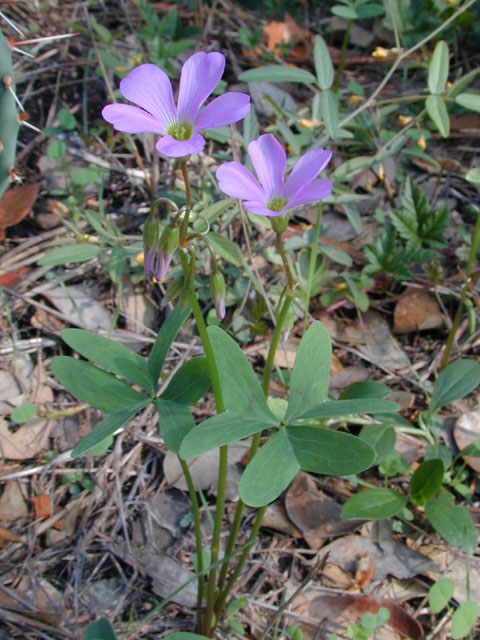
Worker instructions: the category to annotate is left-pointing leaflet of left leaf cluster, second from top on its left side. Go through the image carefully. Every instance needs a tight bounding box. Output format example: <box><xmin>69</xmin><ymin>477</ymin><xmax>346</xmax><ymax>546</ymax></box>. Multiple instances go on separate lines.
<box><xmin>51</xmin><ymin>356</ymin><xmax>148</xmax><ymax>413</ymax></box>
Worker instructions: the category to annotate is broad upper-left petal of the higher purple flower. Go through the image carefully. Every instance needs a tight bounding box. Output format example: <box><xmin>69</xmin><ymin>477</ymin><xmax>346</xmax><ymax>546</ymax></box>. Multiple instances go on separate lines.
<box><xmin>120</xmin><ymin>64</ymin><xmax>176</xmax><ymax>133</ymax></box>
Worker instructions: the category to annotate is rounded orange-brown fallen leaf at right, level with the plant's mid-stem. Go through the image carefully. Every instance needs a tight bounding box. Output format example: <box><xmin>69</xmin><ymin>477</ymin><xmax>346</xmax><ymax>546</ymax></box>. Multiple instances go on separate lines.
<box><xmin>393</xmin><ymin>289</ymin><xmax>444</xmax><ymax>333</ymax></box>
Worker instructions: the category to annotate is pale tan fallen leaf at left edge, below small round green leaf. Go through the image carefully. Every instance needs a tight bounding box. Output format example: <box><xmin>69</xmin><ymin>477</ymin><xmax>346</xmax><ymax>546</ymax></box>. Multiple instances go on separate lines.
<box><xmin>0</xmin><ymin>418</ymin><xmax>53</xmax><ymax>460</ymax></box>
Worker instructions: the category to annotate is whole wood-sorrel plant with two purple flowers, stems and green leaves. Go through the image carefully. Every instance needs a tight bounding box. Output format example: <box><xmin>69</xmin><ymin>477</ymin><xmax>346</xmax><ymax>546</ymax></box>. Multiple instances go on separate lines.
<box><xmin>52</xmin><ymin>52</ymin><xmax>398</xmax><ymax>640</ymax></box>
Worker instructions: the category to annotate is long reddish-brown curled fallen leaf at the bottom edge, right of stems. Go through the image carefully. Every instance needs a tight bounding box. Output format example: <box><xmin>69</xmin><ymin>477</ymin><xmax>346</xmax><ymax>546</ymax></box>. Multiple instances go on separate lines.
<box><xmin>294</xmin><ymin>592</ymin><xmax>424</xmax><ymax>640</ymax></box>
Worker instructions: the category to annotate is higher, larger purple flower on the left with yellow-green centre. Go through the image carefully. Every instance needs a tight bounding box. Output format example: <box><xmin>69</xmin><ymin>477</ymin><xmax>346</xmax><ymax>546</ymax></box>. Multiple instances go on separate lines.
<box><xmin>102</xmin><ymin>51</ymin><xmax>250</xmax><ymax>158</ymax></box>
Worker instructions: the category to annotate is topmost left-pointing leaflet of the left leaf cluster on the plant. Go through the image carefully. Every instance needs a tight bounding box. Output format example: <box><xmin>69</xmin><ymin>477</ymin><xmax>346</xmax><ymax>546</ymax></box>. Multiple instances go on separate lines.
<box><xmin>61</xmin><ymin>329</ymin><xmax>154</xmax><ymax>394</ymax></box>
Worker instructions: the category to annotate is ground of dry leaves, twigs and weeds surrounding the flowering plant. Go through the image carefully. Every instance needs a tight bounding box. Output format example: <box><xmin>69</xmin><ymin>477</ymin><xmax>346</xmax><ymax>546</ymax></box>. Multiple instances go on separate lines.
<box><xmin>0</xmin><ymin>0</ymin><xmax>480</xmax><ymax>640</ymax></box>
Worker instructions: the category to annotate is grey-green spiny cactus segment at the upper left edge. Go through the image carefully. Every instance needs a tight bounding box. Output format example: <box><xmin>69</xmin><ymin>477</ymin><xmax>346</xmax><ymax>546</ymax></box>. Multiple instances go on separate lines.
<box><xmin>0</xmin><ymin>31</ymin><xmax>19</xmax><ymax>196</ymax></box>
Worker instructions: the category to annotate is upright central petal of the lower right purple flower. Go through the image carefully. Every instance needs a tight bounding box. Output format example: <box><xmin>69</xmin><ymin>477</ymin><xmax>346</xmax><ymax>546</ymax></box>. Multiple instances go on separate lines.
<box><xmin>248</xmin><ymin>133</ymin><xmax>287</xmax><ymax>201</ymax></box>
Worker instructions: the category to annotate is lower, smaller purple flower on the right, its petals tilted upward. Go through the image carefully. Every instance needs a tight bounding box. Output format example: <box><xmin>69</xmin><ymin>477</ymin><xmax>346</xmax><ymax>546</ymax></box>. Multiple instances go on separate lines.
<box><xmin>217</xmin><ymin>133</ymin><xmax>332</xmax><ymax>216</ymax></box>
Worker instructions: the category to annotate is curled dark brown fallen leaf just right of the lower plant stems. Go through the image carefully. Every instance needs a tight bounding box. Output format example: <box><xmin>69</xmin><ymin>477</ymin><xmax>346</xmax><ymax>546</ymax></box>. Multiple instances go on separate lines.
<box><xmin>285</xmin><ymin>473</ymin><xmax>363</xmax><ymax>549</ymax></box>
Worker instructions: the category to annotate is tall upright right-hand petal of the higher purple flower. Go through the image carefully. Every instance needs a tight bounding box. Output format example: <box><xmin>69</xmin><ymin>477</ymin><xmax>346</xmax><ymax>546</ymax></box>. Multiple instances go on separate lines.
<box><xmin>177</xmin><ymin>51</ymin><xmax>225</xmax><ymax>122</ymax></box>
